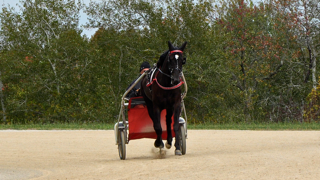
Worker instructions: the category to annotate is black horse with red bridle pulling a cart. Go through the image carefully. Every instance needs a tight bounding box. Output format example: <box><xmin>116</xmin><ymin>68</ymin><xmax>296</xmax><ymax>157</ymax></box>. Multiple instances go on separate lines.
<box><xmin>141</xmin><ymin>41</ymin><xmax>187</xmax><ymax>155</ymax></box>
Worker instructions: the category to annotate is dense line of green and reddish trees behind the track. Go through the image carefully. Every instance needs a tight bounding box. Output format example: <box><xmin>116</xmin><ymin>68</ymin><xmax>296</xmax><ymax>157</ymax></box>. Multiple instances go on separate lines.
<box><xmin>0</xmin><ymin>0</ymin><xmax>320</xmax><ymax>124</ymax></box>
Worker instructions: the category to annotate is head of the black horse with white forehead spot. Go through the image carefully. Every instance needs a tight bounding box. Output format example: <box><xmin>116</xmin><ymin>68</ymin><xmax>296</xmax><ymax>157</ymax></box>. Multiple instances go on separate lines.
<box><xmin>159</xmin><ymin>41</ymin><xmax>187</xmax><ymax>85</ymax></box>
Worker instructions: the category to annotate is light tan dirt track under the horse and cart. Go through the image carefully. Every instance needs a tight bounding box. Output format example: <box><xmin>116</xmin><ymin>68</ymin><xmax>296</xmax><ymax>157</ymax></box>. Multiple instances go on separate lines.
<box><xmin>0</xmin><ymin>130</ymin><xmax>320</xmax><ymax>180</ymax></box>
